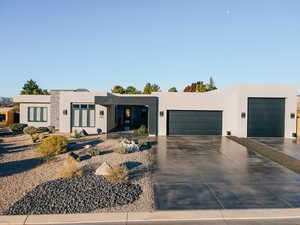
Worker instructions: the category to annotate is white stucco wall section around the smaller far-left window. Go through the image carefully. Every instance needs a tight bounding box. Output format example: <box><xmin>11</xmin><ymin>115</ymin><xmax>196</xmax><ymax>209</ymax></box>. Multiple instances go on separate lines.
<box><xmin>20</xmin><ymin>103</ymin><xmax>50</xmax><ymax>127</ymax></box>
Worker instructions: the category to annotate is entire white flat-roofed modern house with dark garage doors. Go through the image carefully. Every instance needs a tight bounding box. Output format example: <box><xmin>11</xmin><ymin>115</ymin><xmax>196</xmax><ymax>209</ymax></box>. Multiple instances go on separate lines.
<box><xmin>14</xmin><ymin>85</ymin><xmax>297</xmax><ymax>137</ymax></box>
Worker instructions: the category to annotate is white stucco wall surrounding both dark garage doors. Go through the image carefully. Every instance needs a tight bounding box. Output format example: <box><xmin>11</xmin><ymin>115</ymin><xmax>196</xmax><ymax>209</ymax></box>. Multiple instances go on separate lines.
<box><xmin>153</xmin><ymin>85</ymin><xmax>297</xmax><ymax>138</ymax></box>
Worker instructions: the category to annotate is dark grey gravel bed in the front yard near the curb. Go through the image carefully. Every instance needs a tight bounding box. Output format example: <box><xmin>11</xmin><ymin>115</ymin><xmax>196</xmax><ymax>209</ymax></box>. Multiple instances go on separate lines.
<box><xmin>5</xmin><ymin>174</ymin><xmax>142</xmax><ymax>215</ymax></box>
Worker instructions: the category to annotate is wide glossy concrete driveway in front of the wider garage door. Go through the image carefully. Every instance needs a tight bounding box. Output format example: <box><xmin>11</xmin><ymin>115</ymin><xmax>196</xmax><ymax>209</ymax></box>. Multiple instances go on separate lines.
<box><xmin>154</xmin><ymin>136</ymin><xmax>300</xmax><ymax>210</ymax></box>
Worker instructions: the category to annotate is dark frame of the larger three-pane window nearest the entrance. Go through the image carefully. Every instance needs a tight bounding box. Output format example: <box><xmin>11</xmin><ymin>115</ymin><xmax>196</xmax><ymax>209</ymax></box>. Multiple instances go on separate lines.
<box><xmin>71</xmin><ymin>103</ymin><xmax>96</xmax><ymax>127</ymax></box>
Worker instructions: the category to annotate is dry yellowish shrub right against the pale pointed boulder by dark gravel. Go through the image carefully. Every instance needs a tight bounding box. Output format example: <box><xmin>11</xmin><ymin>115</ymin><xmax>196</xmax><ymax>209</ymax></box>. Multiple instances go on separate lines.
<box><xmin>105</xmin><ymin>165</ymin><xmax>128</xmax><ymax>184</ymax></box>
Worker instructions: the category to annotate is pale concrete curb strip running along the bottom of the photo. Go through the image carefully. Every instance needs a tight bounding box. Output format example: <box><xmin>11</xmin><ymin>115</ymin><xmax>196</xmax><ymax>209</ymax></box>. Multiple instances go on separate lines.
<box><xmin>0</xmin><ymin>208</ymin><xmax>300</xmax><ymax>225</ymax></box>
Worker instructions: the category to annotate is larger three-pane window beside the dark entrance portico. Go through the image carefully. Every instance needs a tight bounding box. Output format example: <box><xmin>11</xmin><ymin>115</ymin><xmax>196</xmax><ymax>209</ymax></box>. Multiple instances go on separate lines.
<box><xmin>72</xmin><ymin>104</ymin><xmax>95</xmax><ymax>127</ymax></box>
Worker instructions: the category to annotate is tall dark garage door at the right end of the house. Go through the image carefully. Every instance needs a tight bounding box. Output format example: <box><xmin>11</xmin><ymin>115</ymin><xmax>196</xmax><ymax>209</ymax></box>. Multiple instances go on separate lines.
<box><xmin>247</xmin><ymin>98</ymin><xmax>285</xmax><ymax>137</ymax></box>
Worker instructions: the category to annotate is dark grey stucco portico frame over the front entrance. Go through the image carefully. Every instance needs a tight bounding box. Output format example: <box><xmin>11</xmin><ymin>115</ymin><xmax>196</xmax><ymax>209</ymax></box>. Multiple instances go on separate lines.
<box><xmin>95</xmin><ymin>95</ymin><xmax>158</xmax><ymax>135</ymax></box>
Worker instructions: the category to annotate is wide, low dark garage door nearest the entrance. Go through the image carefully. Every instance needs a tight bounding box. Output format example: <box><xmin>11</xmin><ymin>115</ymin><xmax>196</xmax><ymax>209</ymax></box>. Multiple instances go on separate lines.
<box><xmin>167</xmin><ymin>110</ymin><xmax>222</xmax><ymax>135</ymax></box>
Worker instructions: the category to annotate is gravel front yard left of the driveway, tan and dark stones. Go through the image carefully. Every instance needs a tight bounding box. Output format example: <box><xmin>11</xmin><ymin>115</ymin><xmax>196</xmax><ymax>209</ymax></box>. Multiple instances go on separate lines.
<box><xmin>0</xmin><ymin>134</ymin><xmax>154</xmax><ymax>215</ymax></box>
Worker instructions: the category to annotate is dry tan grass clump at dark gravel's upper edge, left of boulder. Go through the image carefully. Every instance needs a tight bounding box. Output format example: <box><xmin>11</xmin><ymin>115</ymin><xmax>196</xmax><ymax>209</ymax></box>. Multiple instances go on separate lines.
<box><xmin>59</xmin><ymin>156</ymin><xmax>84</xmax><ymax>178</ymax></box>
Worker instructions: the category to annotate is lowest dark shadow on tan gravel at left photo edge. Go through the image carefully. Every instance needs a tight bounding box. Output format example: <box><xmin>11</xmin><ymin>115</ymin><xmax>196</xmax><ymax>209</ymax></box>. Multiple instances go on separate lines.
<box><xmin>0</xmin><ymin>158</ymin><xmax>43</xmax><ymax>177</ymax></box>
